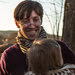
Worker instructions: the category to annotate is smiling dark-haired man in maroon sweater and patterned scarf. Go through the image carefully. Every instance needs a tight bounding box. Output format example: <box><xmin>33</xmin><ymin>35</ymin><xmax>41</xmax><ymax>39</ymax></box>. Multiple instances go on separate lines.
<box><xmin>0</xmin><ymin>0</ymin><xmax>75</xmax><ymax>75</ymax></box>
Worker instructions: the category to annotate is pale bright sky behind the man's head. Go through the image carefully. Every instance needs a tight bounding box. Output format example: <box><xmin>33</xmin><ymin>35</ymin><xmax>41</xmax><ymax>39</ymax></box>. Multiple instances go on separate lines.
<box><xmin>0</xmin><ymin>0</ymin><xmax>63</xmax><ymax>36</ymax></box>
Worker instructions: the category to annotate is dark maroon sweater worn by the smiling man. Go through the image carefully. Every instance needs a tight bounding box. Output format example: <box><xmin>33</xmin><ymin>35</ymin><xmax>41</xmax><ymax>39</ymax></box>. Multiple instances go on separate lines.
<box><xmin>0</xmin><ymin>41</ymin><xmax>75</xmax><ymax>75</ymax></box>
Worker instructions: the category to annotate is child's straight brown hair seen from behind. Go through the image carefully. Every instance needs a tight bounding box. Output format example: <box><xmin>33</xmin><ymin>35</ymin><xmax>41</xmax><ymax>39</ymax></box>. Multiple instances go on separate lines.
<box><xmin>27</xmin><ymin>39</ymin><xmax>63</xmax><ymax>75</ymax></box>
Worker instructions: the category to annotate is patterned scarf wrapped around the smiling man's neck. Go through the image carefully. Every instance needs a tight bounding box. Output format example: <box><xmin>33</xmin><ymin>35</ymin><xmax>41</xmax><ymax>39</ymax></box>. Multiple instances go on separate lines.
<box><xmin>16</xmin><ymin>26</ymin><xmax>47</xmax><ymax>54</ymax></box>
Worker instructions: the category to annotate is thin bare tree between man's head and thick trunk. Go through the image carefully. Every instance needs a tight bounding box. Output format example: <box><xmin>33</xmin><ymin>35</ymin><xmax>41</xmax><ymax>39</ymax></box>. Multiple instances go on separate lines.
<box><xmin>35</xmin><ymin>0</ymin><xmax>64</xmax><ymax>40</ymax></box>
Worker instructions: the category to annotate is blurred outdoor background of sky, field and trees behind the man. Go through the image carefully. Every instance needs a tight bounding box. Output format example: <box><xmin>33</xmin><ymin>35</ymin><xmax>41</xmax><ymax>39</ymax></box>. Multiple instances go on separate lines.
<box><xmin>0</xmin><ymin>0</ymin><xmax>75</xmax><ymax>56</ymax></box>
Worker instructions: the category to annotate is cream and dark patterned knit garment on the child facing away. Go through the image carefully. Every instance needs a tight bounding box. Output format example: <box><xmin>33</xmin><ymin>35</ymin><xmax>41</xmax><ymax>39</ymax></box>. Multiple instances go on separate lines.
<box><xmin>24</xmin><ymin>64</ymin><xmax>75</xmax><ymax>75</ymax></box>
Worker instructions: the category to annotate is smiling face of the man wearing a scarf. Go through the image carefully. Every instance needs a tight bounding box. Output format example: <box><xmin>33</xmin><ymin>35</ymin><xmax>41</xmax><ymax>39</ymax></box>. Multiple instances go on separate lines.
<box><xmin>19</xmin><ymin>11</ymin><xmax>41</xmax><ymax>40</ymax></box>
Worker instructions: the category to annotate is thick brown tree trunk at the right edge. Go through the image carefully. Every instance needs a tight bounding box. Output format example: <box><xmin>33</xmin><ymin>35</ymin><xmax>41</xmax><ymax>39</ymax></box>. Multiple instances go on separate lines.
<box><xmin>62</xmin><ymin>0</ymin><xmax>75</xmax><ymax>53</ymax></box>
